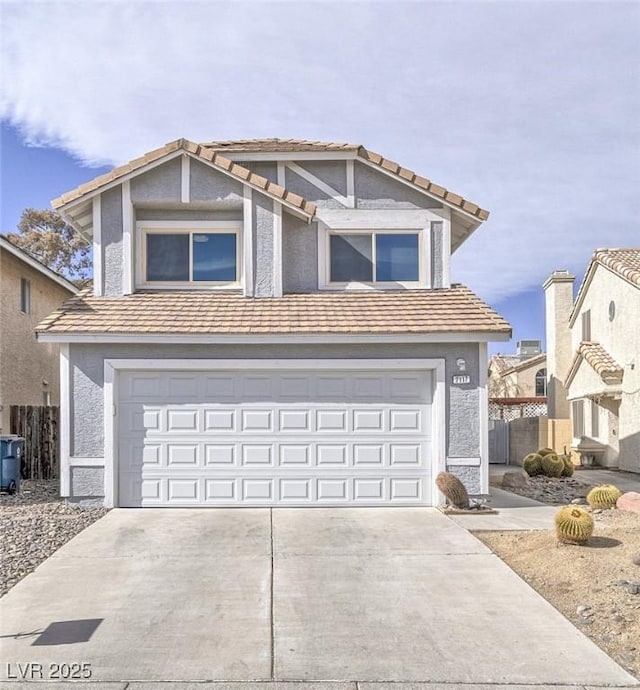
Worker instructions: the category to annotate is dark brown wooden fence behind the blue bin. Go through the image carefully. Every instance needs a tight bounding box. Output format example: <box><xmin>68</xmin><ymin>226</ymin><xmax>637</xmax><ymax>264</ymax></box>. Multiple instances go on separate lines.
<box><xmin>9</xmin><ymin>405</ymin><xmax>60</xmax><ymax>479</ymax></box>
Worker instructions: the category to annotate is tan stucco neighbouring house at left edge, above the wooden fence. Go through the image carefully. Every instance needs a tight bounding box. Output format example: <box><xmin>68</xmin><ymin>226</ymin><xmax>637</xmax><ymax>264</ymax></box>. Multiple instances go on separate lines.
<box><xmin>0</xmin><ymin>235</ymin><xmax>77</xmax><ymax>434</ymax></box>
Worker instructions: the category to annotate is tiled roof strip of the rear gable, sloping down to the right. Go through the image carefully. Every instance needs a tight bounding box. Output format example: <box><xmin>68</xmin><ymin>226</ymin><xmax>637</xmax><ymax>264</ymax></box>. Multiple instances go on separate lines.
<box><xmin>202</xmin><ymin>139</ymin><xmax>489</xmax><ymax>221</ymax></box>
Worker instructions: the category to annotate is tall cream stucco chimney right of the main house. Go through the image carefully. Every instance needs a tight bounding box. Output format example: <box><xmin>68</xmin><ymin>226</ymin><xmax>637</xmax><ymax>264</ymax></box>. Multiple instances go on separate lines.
<box><xmin>542</xmin><ymin>270</ymin><xmax>576</xmax><ymax>419</ymax></box>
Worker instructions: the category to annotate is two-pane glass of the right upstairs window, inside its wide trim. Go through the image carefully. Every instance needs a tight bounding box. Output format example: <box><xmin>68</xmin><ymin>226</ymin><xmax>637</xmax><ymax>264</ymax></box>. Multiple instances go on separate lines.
<box><xmin>329</xmin><ymin>232</ymin><xmax>420</xmax><ymax>283</ymax></box>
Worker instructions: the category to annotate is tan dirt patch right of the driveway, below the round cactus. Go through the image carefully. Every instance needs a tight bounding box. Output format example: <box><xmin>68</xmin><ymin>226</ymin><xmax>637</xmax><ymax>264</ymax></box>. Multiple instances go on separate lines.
<box><xmin>474</xmin><ymin>509</ymin><xmax>640</xmax><ymax>679</ymax></box>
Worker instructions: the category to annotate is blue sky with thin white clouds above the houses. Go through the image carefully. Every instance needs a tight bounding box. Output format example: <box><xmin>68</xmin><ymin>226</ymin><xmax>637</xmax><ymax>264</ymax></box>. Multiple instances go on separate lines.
<box><xmin>0</xmin><ymin>0</ymin><xmax>640</xmax><ymax>352</ymax></box>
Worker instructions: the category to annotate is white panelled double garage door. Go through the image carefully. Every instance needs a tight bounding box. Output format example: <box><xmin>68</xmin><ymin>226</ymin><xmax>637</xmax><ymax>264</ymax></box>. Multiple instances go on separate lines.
<box><xmin>117</xmin><ymin>370</ymin><xmax>433</xmax><ymax>506</ymax></box>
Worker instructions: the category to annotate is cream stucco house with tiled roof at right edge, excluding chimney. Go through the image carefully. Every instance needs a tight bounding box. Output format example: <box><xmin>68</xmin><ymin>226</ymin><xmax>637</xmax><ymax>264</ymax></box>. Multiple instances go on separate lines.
<box><xmin>564</xmin><ymin>249</ymin><xmax>640</xmax><ymax>472</ymax></box>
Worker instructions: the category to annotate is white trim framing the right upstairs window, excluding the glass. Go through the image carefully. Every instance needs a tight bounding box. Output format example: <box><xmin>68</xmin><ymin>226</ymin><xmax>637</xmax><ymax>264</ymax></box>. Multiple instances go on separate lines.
<box><xmin>318</xmin><ymin>225</ymin><xmax>431</xmax><ymax>290</ymax></box>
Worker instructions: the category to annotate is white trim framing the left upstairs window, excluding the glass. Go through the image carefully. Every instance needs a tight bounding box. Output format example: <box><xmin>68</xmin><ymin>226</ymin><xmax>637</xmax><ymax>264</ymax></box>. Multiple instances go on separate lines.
<box><xmin>136</xmin><ymin>220</ymin><xmax>245</xmax><ymax>290</ymax></box>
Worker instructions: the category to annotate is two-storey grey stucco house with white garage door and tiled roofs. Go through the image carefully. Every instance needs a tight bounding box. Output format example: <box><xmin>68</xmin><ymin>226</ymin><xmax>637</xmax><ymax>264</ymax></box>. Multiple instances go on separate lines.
<box><xmin>39</xmin><ymin>139</ymin><xmax>510</xmax><ymax>506</ymax></box>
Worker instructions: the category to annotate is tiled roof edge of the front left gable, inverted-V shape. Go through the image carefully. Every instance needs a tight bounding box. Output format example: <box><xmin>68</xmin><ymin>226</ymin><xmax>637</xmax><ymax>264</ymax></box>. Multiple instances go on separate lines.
<box><xmin>51</xmin><ymin>139</ymin><xmax>316</xmax><ymax>217</ymax></box>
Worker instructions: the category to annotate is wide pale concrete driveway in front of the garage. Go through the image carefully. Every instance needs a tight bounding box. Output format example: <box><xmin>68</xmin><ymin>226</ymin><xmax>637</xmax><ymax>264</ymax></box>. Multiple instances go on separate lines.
<box><xmin>0</xmin><ymin>508</ymin><xmax>636</xmax><ymax>685</ymax></box>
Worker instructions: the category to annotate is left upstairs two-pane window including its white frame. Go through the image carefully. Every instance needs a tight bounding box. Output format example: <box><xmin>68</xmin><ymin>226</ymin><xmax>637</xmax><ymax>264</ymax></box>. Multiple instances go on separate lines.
<box><xmin>138</xmin><ymin>221</ymin><xmax>241</xmax><ymax>287</ymax></box>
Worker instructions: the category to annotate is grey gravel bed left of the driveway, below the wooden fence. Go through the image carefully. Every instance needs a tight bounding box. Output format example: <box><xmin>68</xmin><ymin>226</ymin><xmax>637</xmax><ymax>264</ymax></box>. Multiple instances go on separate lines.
<box><xmin>0</xmin><ymin>480</ymin><xmax>107</xmax><ymax>597</ymax></box>
